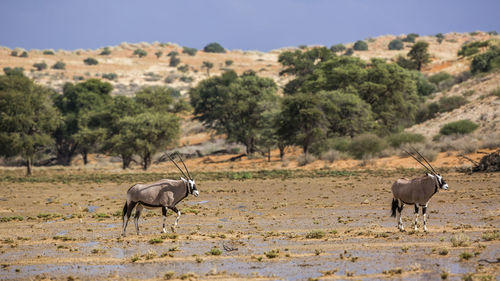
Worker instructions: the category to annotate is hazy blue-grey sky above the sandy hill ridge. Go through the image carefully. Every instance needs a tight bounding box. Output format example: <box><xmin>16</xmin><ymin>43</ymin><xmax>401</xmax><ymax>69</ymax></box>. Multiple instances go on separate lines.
<box><xmin>0</xmin><ymin>0</ymin><xmax>500</xmax><ymax>51</ymax></box>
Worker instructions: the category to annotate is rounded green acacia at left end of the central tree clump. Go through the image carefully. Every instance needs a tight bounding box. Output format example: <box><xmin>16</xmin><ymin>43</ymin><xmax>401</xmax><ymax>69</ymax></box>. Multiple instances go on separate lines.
<box><xmin>189</xmin><ymin>71</ymin><xmax>277</xmax><ymax>154</ymax></box>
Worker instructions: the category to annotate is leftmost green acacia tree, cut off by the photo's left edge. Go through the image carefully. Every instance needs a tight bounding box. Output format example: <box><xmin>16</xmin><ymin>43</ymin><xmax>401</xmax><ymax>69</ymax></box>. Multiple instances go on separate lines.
<box><xmin>0</xmin><ymin>75</ymin><xmax>61</xmax><ymax>176</ymax></box>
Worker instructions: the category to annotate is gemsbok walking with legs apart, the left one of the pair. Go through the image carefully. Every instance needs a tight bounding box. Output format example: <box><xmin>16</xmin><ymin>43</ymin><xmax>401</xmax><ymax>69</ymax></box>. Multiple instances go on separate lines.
<box><xmin>122</xmin><ymin>154</ymin><xmax>199</xmax><ymax>236</ymax></box>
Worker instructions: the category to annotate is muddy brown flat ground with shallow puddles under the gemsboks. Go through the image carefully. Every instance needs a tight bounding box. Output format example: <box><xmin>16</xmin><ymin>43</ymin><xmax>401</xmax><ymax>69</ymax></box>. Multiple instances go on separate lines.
<box><xmin>0</xmin><ymin>172</ymin><xmax>500</xmax><ymax>280</ymax></box>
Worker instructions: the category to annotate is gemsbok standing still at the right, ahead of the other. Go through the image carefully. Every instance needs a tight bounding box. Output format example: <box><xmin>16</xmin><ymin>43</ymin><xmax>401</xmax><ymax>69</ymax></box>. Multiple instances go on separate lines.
<box><xmin>391</xmin><ymin>148</ymin><xmax>448</xmax><ymax>231</ymax></box>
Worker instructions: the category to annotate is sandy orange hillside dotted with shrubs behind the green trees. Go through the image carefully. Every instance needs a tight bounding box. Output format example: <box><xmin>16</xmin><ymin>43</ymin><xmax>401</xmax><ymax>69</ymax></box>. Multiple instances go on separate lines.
<box><xmin>0</xmin><ymin>32</ymin><xmax>500</xmax><ymax>170</ymax></box>
